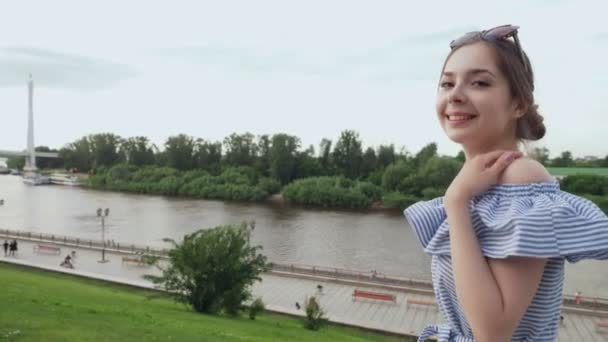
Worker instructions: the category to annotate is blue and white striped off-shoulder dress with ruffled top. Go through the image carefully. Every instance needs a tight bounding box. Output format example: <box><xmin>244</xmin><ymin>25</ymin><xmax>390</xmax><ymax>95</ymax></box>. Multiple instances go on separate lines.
<box><xmin>404</xmin><ymin>180</ymin><xmax>608</xmax><ymax>342</ymax></box>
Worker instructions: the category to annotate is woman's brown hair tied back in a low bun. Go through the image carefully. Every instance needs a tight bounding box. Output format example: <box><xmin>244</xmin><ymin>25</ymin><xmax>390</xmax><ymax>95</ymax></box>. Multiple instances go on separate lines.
<box><xmin>442</xmin><ymin>35</ymin><xmax>545</xmax><ymax>140</ymax></box>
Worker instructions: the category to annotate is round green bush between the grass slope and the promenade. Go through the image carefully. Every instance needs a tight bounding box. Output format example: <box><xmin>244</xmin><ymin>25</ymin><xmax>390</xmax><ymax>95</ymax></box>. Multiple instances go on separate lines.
<box><xmin>145</xmin><ymin>224</ymin><xmax>269</xmax><ymax>315</ymax></box>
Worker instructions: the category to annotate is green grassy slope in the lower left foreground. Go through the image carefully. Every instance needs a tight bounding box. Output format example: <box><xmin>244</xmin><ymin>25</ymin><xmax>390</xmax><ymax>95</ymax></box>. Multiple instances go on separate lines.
<box><xmin>0</xmin><ymin>262</ymin><xmax>413</xmax><ymax>342</ymax></box>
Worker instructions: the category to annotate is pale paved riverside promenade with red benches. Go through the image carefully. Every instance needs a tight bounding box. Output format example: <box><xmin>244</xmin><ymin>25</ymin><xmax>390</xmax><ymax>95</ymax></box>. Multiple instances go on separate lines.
<box><xmin>0</xmin><ymin>241</ymin><xmax>608</xmax><ymax>342</ymax></box>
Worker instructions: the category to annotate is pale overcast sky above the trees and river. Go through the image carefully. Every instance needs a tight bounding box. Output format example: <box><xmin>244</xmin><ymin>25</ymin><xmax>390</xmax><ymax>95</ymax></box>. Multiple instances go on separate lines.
<box><xmin>0</xmin><ymin>0</ymin><xmax>608</xmax><ymax>157</ymax></box>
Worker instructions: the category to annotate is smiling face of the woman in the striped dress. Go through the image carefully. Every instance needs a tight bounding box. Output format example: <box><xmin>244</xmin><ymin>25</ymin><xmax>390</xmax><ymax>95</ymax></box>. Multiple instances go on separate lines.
<box><xmin>436</xmin><ymin>42</ymin><xmax>523</xmax><ymax>148</ymax></box>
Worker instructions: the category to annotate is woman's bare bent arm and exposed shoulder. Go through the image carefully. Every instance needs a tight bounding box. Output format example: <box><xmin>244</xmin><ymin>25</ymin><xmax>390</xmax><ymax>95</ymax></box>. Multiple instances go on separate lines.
<box><xmin>444</xmin><ymin>157</ymin><xmax>548</xmax><ymax>342</ymax></box>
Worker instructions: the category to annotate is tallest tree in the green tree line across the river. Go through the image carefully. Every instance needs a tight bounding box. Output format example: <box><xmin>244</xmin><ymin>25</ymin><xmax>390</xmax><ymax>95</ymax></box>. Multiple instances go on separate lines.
<box><xmin>332</xmin><ymin>130</ymin><xmax>363</xmax><ymax>178</ymax></box>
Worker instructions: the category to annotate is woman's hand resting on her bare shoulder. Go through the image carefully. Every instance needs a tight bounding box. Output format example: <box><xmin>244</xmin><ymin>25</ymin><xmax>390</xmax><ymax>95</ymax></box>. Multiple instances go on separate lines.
<box><xmin>445</xmin><ymin>150</ymin><xmax>523</xmax><ymax>203</ymax></box>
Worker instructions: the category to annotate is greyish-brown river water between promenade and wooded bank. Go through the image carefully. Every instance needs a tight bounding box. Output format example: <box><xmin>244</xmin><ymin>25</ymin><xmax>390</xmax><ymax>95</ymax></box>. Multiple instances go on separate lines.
<box><xmin>0</xmin><ymin>176</ymin><xmax>608</xmax><ymax>298</ymax></box>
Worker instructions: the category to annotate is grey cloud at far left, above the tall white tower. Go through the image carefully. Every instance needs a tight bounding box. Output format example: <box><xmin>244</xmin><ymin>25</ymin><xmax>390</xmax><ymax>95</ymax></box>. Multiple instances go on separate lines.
<box><xmin>0</xmin><ymin>47</ymin><xmax>137</xmax><ymax>90</ymax></box>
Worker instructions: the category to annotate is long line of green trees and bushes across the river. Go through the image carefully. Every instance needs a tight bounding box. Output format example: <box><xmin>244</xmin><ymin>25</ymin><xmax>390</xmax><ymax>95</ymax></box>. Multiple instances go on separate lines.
<box><xmin>8</xmin><ymin>130</ymin><xmax>608</xmax><ymax>208</ymax></box>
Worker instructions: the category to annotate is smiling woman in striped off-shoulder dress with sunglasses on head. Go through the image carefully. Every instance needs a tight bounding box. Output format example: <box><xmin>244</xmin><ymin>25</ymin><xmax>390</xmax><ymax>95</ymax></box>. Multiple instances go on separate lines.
<box><xmin>405</xmin><ymin>25</ymin><xmax>608</xmax><ymax>342</ymax></box>
